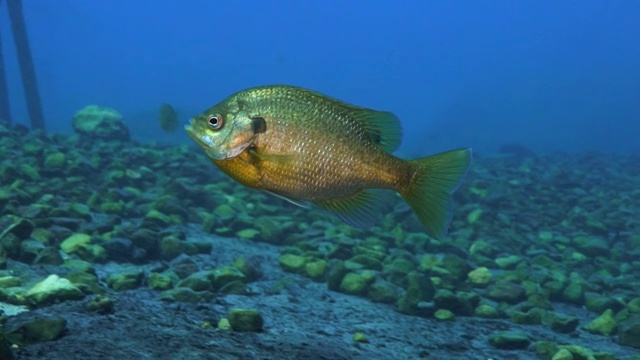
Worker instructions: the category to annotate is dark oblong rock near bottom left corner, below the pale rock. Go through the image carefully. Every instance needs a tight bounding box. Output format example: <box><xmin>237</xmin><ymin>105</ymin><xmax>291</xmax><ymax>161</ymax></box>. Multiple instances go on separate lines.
<box><xmin>5</xmin><ymin>317</ymin><xmax>67</xmax><ymax>345</ymax></box>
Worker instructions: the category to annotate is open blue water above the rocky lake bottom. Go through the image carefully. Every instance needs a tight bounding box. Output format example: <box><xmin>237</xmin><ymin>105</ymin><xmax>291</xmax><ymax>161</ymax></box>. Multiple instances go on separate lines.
<box><xmin>0</xmin><ymin>0</ymin><xmax>640</xmax><ymax>155</ymax></box>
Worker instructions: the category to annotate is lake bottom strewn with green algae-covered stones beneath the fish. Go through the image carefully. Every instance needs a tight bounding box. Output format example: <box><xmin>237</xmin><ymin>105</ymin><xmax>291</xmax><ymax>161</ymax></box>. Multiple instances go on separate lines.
<box><xmin>0</xmin><ymin>124</ymin><xmax>640</xmax><ymax>360</ymax></box>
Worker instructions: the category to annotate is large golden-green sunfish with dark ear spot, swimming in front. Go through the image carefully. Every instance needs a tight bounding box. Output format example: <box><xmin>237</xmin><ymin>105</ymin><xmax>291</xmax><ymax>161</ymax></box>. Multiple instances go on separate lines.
<box><xmin>184</xmin><ymin>85</ymin><xmax>471</xmax><ymax>239</ymax></box>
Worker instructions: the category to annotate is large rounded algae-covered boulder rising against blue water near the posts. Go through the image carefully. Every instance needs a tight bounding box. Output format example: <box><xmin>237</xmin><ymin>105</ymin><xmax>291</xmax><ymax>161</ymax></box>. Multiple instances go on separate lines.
<box><xmin>73</xmin><ymin>105</ymin><xmax>130</xmax><ymax>141</ymax></box>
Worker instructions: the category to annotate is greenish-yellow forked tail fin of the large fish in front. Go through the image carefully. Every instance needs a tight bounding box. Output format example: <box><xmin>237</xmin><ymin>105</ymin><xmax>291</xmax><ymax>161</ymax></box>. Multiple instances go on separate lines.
<box><xmin>401</xmin><ymin>149</ymin><xmax>471</xmax><ymax>239</ymax></box>
